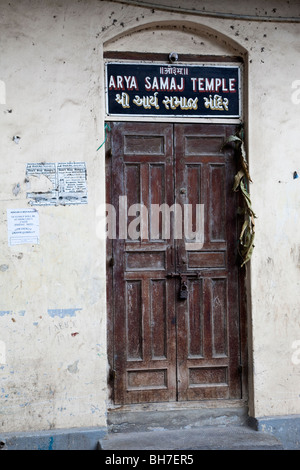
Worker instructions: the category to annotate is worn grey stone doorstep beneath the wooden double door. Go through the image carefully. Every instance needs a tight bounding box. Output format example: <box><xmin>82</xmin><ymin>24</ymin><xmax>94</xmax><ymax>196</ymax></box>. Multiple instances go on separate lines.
<box><xmin>99</xmin><ymin>408</ymin><xmax>284</xmax><ymax>451</ymax></box>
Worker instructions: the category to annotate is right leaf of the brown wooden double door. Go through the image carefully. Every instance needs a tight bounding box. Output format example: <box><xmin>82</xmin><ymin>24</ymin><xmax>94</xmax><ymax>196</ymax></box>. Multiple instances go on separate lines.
<box><xmin>174</xmin><ymin>124</ymin><xmax>240</xmax><ymax>400</ymax></box>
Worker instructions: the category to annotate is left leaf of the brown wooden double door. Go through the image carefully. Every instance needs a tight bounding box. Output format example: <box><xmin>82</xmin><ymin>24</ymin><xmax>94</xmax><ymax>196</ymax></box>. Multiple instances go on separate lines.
<box><xmin>111</xmin><ymin>123</ymin><xmax>176</xmax><ymax>403</ymax></box>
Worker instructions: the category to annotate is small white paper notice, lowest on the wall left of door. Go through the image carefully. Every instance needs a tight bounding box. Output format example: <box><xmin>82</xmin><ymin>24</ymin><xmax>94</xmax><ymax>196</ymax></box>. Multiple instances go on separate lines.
<box><xmin>7</xmin><ymin>209</ymin><xmax>40</xmax><ymax>246</ymax></box>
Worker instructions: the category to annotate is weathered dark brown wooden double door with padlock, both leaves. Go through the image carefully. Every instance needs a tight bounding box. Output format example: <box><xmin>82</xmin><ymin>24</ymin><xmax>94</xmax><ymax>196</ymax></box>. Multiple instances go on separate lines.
<box><xmin>107</xmin><ymin>122</ymin><xmax>241</xmax><ymax>404</ymax></box>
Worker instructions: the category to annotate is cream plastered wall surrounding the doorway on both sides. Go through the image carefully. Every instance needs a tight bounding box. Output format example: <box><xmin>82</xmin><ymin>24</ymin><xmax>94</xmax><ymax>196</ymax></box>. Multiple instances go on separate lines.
<box><xmin>0</xmin><ymin>0</ymin><xmax>300</xmax><ymax>432</ymax></box>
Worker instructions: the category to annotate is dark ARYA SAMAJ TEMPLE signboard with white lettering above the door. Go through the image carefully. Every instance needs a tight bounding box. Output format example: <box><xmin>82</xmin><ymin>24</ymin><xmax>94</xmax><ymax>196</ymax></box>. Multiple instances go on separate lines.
<box><xmin>106</xmin><ymin>63</ymin><xmax>241</xmax><ymax>118</ymax></box>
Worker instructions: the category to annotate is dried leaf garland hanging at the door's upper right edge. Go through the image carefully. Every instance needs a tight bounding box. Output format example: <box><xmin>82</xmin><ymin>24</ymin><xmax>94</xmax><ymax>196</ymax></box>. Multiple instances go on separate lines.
<box><xmin>222</xmin><ymin>129</ymin><xmax>256</xmax><ymax>266</ymax></box>
